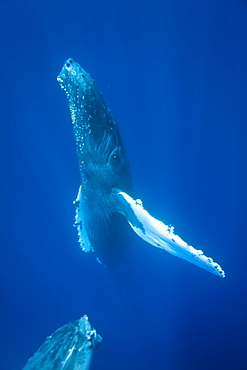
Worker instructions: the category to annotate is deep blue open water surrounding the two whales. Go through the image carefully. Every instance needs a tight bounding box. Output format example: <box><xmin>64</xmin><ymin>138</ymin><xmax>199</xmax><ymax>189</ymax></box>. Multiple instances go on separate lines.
<box><xmin>0</xmin><ymin>0</ymin><xmax>247</xmax><ymax>370</ymax></box>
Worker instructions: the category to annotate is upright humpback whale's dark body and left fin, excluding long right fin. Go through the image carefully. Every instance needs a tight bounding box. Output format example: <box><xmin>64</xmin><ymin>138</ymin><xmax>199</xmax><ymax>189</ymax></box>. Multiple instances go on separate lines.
<box><xmin>58</xmin><ymin>59</ymin><xmax>132</xmax><ymax>265</ymax></box>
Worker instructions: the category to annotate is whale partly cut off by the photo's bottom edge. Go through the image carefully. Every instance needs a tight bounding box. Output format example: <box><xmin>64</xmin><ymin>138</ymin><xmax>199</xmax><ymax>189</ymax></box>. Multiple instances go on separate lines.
<box><xmin>23</xmin><ymin>315</ymin><xmax>102</xmax><ymax>370</ymax></box>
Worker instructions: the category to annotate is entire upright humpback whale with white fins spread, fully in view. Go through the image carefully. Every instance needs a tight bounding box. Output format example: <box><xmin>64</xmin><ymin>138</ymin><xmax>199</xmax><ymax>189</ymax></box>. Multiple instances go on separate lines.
<box><xmin>57</xmin><ymin>59</ymin><xmax>225</xmax><ymax>277</ymax></box>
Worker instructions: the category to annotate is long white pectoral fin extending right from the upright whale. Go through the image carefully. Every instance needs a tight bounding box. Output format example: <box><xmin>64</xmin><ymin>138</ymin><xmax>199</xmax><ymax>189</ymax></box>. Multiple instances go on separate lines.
<box><xmin>111</xmin><ymin>188</ymin><xmax>225</xmax><ymax>278</ymax></box>
